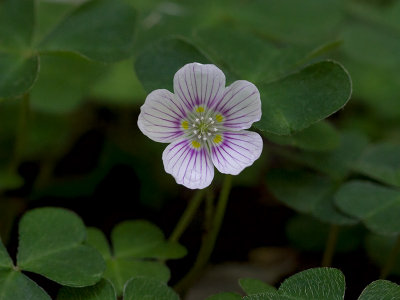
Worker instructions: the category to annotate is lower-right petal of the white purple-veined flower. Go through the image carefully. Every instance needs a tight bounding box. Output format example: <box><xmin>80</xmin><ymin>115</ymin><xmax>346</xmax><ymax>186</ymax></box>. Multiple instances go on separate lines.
<box><xmin>211</xmin><ymin>130</ymin><xmax>263</xmax><ymax>175</ymax></box>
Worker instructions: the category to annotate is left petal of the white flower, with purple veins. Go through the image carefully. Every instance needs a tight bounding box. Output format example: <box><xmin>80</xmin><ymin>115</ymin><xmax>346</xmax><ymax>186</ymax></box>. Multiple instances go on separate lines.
<box><xmin>138</xmin><ymin>90</ymin><xmax>186</xmax><ymax>143</ymax></box>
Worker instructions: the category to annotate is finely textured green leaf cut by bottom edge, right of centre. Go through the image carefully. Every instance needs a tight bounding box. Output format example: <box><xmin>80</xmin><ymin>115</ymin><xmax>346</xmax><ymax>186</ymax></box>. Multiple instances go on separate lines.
<box><xmin>243</xmin><ymin>268</ymin><xmax>345</xmax><ymax>300</ymax></box>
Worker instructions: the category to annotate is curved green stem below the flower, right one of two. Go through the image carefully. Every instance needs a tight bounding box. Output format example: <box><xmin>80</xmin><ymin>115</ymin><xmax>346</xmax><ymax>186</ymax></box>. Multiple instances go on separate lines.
<box><xmin>175</xmin><ymin>175</ymin><xmax>232</xmax><ymax>292</ymax></box>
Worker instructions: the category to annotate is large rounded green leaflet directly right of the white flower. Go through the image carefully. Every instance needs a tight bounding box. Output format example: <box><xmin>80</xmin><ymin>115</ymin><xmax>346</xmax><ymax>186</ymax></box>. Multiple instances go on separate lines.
<box><xmin>254</xmin><ymin>61</ymin><xmax>352</xmax><ymax>135</ymax></box>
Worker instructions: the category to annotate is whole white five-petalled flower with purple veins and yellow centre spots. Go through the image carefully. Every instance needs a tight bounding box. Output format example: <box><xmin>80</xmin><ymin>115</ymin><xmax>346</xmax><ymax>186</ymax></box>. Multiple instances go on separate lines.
<box><xmin>138</xmin><ymin>63</ymin><xmax>263</xmax><ymax>189</ymax></box>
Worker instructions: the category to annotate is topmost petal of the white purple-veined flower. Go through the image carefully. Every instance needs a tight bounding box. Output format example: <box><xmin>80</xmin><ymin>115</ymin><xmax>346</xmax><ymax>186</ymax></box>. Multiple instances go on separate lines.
<box><xmin>174</xmin><ymin>63</ymin><xmax>225</xmax><ymax>110</ymax></box>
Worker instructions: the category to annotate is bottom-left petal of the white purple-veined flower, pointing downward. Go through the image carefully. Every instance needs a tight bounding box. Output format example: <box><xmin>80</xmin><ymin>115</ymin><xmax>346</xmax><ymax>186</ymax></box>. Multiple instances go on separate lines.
<box><xmin>162</xmin><ymin>139</ymin><xmax>214</xmax><ymax>189</ymax></box>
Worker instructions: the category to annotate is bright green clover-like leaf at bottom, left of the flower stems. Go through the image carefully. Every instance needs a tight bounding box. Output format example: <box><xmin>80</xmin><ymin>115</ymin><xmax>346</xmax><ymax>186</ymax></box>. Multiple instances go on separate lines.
<box><xmin>87</xmin><ymin>221</ymin><xmax>186</xmax><ymax>295</ymax></box>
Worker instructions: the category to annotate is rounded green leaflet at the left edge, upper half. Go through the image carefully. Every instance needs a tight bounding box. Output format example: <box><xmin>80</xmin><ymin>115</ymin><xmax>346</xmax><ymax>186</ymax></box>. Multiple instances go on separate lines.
<box><xmin>0</xmin><ymin>49</ymin><xmax>39</xmax><ymax>99</ymax></box>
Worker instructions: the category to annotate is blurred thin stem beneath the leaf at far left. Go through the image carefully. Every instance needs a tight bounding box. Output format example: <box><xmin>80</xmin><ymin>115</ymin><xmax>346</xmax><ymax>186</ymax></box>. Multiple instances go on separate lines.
<box><xmin>10</xmin><ymin>94</ymin><xmax>29</xmax><ymax>171</ymax></box>
